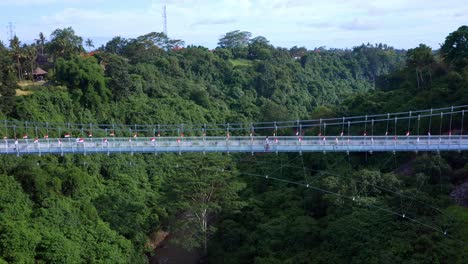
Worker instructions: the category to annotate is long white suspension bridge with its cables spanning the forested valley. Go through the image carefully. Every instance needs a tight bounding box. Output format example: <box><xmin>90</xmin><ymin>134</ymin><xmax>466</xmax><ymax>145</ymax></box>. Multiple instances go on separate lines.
<box><xmin>0</xmin><ymin>105</ymin><xmax>468</xmax><ymax>156</ymax></box>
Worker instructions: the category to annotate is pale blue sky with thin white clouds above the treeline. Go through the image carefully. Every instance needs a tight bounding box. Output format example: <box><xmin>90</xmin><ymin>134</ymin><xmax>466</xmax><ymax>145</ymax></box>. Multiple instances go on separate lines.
<box><xmin>0</xmin><ymin>0</ymin><xmax>468</xmax><ymax>49</ymax></box>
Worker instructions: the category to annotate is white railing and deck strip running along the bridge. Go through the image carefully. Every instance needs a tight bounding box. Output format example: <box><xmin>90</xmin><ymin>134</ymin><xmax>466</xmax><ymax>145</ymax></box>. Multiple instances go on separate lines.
<box><xmin>0</xmin><ymin>135</ymin><xmax>468</xmax><ymax>154</ymax></box>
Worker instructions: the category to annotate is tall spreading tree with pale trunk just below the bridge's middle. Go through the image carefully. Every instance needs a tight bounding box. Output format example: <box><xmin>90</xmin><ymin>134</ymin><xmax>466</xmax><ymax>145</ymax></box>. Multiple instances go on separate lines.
<box><xmin>167</xmin><ymin>155</ymin><xmax>245</xmax><ymax>255</ymax></box>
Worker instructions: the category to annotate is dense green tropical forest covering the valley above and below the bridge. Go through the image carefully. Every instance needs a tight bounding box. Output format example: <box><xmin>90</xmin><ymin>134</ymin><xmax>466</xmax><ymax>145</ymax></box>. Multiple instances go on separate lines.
<box><xmin>0</xmin><ymin>26</ymin><xmax>468</xmax><ymax>264</ymax></box>
